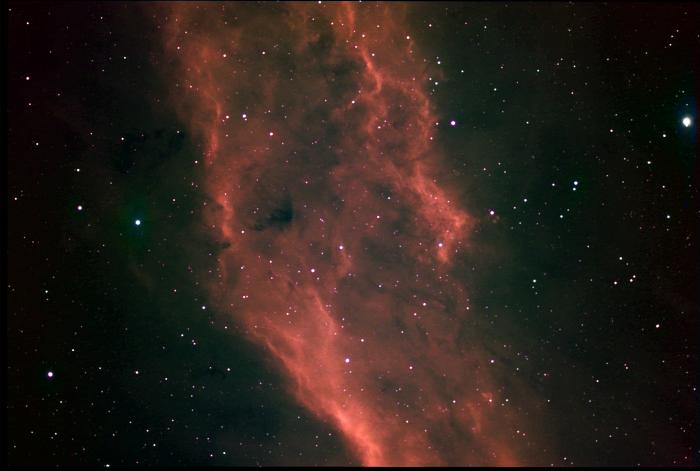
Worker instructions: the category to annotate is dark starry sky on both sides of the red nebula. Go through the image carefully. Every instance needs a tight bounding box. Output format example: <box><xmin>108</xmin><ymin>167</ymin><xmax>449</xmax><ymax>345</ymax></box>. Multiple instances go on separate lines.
<box><xmin>5</xmin><ymin>2</ymin><xmax>700</xmax><ymax>466</ymax></box>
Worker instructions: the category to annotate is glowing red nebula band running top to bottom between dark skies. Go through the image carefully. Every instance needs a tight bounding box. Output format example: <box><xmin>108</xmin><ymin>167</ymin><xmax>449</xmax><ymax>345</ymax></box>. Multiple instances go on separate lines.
<box><xmin>163</xmin><ymin>3</ymin><xmax>540</xmax><ymax>465</ymax></box>
